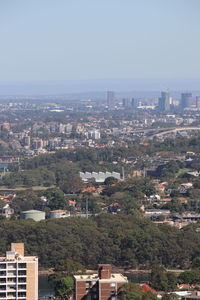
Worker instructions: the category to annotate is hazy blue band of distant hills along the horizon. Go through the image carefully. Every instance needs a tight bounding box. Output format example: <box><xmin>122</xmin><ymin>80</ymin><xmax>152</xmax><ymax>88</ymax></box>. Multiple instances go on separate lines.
<box><xmin>0</xmin><ymin>78</ymin><xmax>200</xmax><ymax>97</ymax></box>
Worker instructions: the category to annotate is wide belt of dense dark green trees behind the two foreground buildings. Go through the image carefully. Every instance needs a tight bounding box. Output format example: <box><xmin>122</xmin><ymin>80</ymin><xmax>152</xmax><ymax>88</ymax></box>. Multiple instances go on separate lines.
<box><xmin>0</xmin><ymin>214</ymin><xmax>200</xmax><ymax>268</ymax></box>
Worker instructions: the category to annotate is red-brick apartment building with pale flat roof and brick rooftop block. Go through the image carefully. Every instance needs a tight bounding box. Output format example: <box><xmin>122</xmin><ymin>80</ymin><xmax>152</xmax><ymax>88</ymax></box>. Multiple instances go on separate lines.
<box><xmin>74</xmin><ymin>264</ymin><xmax>128</xmax><ymax>300</ymax></box>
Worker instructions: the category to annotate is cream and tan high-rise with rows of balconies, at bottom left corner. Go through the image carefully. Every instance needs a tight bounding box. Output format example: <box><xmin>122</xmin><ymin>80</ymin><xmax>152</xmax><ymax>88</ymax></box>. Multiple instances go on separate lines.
<box><xmin>0</xmin><ymin>243</ymin><xmax>38</xmax><ymax>300</ymax></box>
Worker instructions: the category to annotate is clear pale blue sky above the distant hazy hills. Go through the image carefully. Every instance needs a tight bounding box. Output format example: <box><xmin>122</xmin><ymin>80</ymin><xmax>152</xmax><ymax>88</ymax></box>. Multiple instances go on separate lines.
<box><xmin>0</xmin><ymin>0</ymin><xmax>200</xmax><ymax>81</ymax></box>
